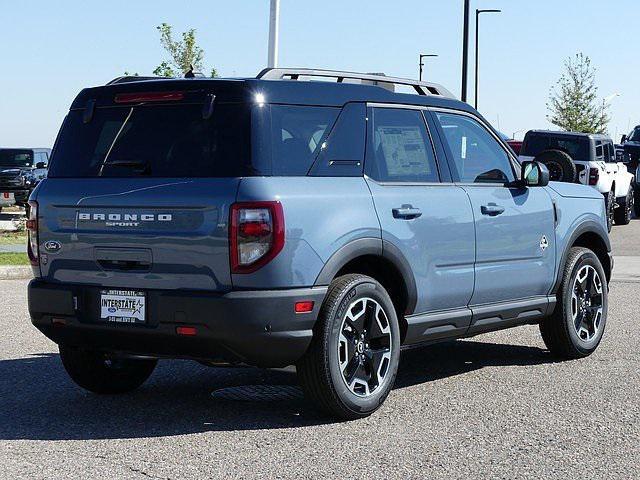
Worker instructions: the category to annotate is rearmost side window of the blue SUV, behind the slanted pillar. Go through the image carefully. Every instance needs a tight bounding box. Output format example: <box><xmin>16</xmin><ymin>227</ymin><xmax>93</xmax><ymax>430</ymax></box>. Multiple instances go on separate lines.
<box><xmin>271</xmin><ymin>105</ymin><xmax>340</xmax><ymax>176</ymax></box>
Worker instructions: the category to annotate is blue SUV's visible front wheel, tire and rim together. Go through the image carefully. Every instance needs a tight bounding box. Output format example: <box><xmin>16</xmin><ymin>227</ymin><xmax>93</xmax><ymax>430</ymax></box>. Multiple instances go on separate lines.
<box><xmin>540</xmin><ymin>247</ymin><xmax>609</xmax><ymax>359</ymax></box>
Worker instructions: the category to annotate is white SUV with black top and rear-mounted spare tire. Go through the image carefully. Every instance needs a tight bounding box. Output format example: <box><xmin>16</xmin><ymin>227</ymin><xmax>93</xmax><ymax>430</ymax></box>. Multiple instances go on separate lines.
<box><xmin>520</xmin><ymin>130</ymin><xmax>635</xmax><ymax>231</ymax></box>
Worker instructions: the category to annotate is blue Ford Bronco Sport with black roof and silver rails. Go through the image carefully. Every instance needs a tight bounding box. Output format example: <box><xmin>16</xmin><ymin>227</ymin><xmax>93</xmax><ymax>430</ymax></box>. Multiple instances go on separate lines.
<box><xmin>27</xmin><ymin>69</ymin><xmax>613</xmax><ymax>419</ymax></box>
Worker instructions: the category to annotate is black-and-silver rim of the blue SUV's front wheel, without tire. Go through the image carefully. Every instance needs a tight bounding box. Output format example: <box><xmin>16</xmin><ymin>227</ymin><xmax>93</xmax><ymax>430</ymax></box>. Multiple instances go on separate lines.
<box><xmin>571</xmin><ymin>265</ymin><xmax>604</xmax><ymax>342</ymax></box>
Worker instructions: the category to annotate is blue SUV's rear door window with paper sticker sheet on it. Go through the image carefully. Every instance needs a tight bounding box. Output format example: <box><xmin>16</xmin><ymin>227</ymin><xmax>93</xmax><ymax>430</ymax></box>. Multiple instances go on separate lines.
<box><xmin>367</xmin><ymin>108</ymin><xmax>440</xmax><ymax>183</ymax></box>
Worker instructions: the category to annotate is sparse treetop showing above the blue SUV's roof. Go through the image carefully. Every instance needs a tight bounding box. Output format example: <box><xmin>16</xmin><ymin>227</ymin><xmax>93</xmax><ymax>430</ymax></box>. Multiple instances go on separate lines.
<box><xmin>153</xmin><ymin>23</ymin><xmax>218</xmax><ymax>77</ymax></box>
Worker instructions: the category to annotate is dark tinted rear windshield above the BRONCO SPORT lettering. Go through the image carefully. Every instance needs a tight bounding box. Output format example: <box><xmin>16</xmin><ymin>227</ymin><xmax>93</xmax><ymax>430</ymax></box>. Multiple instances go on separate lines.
<box><xmin>49</xmin><ymin>103</ymin><xmax>251</xmax><ymax>177</ymax></box>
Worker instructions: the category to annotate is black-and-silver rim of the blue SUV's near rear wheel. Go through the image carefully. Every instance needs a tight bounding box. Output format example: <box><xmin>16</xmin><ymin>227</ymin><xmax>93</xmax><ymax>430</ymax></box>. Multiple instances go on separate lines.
<box><xmin>338</xmin><ymin>298</ymin><xmax>393</xmax><ymax>397</ymax></box>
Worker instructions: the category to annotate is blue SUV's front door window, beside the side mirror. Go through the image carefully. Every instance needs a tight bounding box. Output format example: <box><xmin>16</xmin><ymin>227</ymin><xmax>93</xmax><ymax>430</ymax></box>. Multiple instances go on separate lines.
<box><xmin>436</xmin><ymin>113</ymin><xmax>515</xmax><ymax>183</ymax></box>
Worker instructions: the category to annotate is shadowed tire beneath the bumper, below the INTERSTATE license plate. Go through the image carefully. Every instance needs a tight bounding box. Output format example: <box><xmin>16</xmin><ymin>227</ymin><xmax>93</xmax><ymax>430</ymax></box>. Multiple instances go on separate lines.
<box><xmin>59</xmin><ymin>345</ymin><xmax>157</xmax><ymax>394</ymax></box>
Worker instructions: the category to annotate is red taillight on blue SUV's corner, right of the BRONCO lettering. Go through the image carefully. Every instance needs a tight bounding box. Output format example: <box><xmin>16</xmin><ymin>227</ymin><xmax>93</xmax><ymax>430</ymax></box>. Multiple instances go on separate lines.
<box><xmin>229</xmin><ymin>202</ymin><xmax>284</xmax><ymax>273</ymax></box>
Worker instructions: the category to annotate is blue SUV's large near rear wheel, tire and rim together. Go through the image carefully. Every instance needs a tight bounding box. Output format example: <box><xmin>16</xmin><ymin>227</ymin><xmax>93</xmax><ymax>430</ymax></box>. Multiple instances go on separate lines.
<box><xmin>296</xmin><ymin>274</ymin><xmax>400</xmax><ymax>420</ymax></box>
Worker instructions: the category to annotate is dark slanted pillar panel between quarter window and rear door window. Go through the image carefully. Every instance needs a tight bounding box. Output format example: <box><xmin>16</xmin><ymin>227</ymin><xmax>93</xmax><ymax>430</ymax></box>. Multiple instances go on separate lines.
<box><xmin>310</xmin><ymin>103</ymin><xmax>367</xmax><ymax>177</ymax></box>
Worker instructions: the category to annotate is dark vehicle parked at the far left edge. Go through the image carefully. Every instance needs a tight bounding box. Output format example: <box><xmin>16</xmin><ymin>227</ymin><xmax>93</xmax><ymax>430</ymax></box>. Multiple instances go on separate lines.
<box><xmin>0</xmin><ymin>148</ymin><xmax>51</xmax><ymax>211</ymax></box>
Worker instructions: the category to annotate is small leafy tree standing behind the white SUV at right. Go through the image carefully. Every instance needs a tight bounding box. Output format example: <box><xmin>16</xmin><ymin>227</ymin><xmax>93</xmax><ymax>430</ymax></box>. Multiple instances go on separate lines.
<box><xmin>547</xmin><ymin>53</ymin><xmax>610</xmax><ymax>133</ymax></box>
